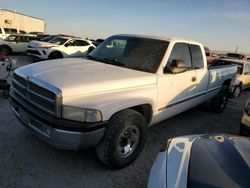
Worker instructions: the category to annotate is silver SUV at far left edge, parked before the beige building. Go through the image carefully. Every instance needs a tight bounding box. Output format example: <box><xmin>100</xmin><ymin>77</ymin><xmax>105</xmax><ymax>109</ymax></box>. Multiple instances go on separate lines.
<box><xmin>0</xmin><ymin>34</ymin><xmax>37</xmax><ymax>55</ymax></box>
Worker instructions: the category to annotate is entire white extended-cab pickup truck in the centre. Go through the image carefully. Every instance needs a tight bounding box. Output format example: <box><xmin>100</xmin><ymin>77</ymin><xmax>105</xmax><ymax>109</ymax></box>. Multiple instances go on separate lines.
<box><xmin>10</xmin><ymin>35</ymin><xmax>237</xmax><ymax>168</ymax></box>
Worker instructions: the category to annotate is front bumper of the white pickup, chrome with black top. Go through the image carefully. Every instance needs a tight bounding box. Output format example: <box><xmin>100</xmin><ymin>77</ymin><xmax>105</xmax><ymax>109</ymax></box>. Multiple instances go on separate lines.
<box><xmin>10</xmin><ymin>96</ymin><xmax>107</xmax><ymax>150</ymax></box>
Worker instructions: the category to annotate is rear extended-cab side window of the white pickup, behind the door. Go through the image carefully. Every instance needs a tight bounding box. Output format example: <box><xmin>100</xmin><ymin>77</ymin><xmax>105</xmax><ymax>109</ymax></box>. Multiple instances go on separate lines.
<box><xmin>189</xmin><ymin>44</ymin><xmax>204</xmax><ymax>69</ymax></box>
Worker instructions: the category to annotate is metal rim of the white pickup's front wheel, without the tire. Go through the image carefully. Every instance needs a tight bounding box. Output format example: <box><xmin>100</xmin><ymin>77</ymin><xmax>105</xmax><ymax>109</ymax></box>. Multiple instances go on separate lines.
<box><xmin>116</xmin><ymin>125</ymin><xmax>140</xmax><ymax>158</ymax></box>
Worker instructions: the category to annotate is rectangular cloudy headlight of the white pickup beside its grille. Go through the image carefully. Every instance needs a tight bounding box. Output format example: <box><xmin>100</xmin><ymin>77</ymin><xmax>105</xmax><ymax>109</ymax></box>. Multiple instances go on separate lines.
<box><xmin>62</xmin><ymin>106</ymin><xmax>102</xmax><ymax>122</ymax></box>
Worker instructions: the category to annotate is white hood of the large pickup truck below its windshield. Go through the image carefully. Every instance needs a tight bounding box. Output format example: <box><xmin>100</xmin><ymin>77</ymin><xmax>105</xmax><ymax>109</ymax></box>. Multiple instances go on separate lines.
<box><xmin>15</xmin><ymin>58</ymin><xmax>157</xmax><ymax>97</ymax></box>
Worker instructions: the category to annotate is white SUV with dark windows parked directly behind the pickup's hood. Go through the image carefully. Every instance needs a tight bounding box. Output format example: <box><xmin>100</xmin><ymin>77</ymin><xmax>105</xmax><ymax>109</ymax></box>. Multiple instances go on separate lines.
<box><xmin>27</xmin><ymin>37</ymin><xmax>95</xmax><ymax>60</ymax></box>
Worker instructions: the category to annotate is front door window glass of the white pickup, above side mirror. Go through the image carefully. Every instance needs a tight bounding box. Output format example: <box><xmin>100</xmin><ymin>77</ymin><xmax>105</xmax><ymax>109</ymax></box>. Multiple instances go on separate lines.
<box><xmin>168</xmin><ymin>43</ymin><xmax>192</xmax><ymax>69</ymax></box>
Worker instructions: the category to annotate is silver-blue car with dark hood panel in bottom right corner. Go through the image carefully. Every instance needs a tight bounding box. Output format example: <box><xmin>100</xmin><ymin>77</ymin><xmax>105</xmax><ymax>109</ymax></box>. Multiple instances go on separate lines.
<box><xmin>148</xmin><ymin>135</ymin><xmax>250</xmax><ymax>188</ymax></box>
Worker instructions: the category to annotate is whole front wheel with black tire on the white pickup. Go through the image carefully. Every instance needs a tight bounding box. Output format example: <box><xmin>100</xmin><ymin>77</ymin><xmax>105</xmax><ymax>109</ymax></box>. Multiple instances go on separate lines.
<box><xmin>96</xmin><ymin>109</ymin><xmax>147</xmax><ymax>169</ymax></box>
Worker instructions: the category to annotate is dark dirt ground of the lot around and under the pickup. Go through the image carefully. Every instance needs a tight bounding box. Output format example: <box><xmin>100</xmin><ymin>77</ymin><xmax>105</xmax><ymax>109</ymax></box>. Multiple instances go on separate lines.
<box><xmin>0</xmin><ymin>56</ymin><xmax>250</xmax><ymax>188</ymax></box>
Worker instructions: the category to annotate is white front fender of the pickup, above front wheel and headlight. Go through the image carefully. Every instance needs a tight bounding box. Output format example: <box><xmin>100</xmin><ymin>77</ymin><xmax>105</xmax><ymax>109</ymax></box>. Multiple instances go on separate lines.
<box><xmin>63</xmin><ymin>85</ymin><xmax>157</xmax><ymax>121</ymax></box>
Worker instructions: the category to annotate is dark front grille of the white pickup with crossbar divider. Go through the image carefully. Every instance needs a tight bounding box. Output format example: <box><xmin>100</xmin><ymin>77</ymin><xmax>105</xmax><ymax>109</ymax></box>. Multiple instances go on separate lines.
<box><xmin>12</xmin><ymin>73</ymin><xmax>60</xmax><ymax>116</ymax></box>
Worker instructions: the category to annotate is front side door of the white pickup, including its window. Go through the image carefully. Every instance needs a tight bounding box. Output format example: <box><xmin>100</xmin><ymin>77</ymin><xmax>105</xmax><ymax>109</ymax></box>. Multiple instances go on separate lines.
<box><xmin>157</xmin><ymin>43</ymin><xmax>197</xmax><ymax>120</ymax></box>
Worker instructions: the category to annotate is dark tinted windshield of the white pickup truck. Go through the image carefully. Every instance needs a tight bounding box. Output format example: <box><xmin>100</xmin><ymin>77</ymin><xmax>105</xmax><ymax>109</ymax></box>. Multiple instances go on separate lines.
<box><xmin>87</xmin><ymin>36</ymin><xmax>169</xmax><ymax>73</ymax></box>
